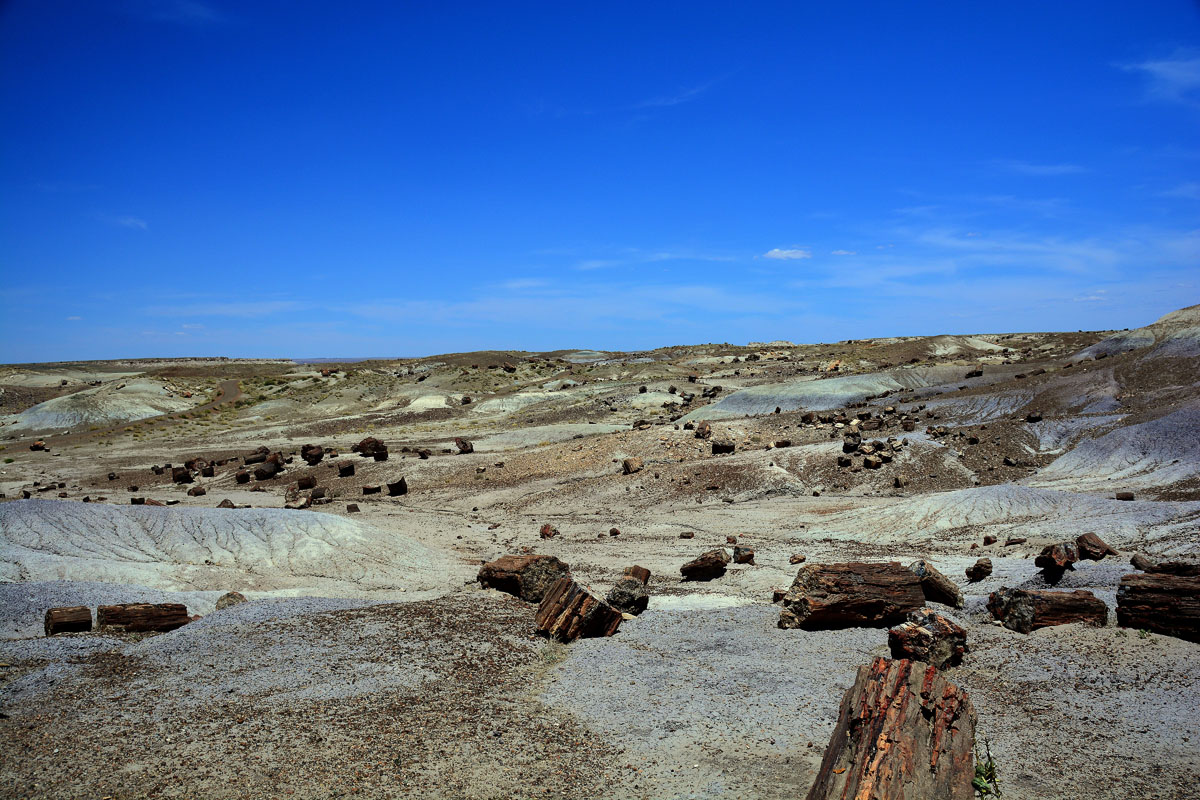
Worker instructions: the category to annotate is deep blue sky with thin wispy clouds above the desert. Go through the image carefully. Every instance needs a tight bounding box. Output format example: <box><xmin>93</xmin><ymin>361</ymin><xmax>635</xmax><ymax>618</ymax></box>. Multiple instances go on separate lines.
<box><xmin>0</xmin><ymin>0</ymin><xmax>1200</xmax><ymax>362</ymax></box>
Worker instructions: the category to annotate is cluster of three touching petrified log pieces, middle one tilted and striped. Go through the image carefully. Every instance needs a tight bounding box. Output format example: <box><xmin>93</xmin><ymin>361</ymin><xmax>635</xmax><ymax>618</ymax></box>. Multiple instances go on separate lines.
<box><xmin>478</xmin><ymin>554</ymin><xmax>650</xmax><ymax>642</ymax></box>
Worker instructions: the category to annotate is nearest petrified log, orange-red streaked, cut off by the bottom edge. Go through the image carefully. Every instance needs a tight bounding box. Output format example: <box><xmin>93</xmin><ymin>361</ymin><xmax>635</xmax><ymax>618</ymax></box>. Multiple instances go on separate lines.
<box><xmin>808</xmin><ymin>658</ymin><xmax>976</xmax><ymax>800</ymax></box>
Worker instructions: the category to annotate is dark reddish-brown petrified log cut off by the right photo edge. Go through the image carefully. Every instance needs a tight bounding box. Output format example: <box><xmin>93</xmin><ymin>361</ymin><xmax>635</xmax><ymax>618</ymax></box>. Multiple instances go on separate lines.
<box><xmin>1117</xmin><ymin>573</ymin><xmax>1200</xmax><ymax>642</ymax></box>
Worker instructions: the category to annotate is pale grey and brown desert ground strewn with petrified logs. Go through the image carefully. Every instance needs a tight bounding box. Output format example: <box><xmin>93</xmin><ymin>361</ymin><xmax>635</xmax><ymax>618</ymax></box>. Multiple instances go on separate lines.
<box><xmin>0</xmin><ymin>306</ymin><xmax>1200</xmax><ymax>800</ymax></box>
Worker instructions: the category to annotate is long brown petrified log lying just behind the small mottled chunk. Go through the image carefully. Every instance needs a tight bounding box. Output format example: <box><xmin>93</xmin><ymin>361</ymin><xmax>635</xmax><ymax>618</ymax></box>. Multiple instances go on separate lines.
<box><xmin>779</xmin><ymin>561</ymin><xmax>925</xmax><ymax>630</ymax></box>
